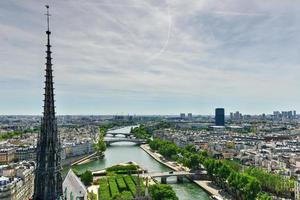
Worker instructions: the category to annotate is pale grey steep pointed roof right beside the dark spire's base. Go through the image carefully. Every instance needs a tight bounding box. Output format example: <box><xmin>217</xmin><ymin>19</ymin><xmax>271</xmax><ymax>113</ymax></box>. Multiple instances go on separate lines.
<box><xmin>63</xmin><ymin>169</ymin><xmax>87</xmax><ymax>200</ymax></box>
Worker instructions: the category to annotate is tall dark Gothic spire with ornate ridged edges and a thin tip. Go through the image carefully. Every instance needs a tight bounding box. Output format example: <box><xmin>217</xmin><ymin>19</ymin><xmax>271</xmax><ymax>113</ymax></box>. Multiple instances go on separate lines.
<box><xmin>33</xmin><ymin>6</ymin><xmax>62</xmax><ymax>200</ymax></box>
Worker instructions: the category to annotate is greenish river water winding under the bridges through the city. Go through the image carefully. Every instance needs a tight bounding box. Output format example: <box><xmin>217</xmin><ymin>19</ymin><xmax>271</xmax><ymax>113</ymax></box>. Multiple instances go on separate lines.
<box><xmin>74</xmin><ymin>127</ymin><xmax>210</xmax><ymax>200</ymax></box>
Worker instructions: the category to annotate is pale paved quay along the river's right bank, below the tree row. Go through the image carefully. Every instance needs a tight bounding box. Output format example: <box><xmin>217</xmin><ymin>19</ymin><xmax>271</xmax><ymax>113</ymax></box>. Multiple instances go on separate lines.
<box><xmin>140</xmin><ymin>144</ymin><xmax>232</xmax><ymax>200</ymax></box>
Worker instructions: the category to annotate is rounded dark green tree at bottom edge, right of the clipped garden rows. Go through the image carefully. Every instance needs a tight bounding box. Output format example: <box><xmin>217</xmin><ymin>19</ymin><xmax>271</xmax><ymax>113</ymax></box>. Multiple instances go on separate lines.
<box><xmin>149</xmin><ymin>184</ymin><xmax>178</xmax><ymax>200</ymax></box>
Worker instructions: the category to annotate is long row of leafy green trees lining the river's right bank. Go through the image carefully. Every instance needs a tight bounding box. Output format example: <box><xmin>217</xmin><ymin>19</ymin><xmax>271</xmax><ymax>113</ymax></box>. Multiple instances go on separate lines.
<box><xmin>149</xmin><ymin>139</ymin><xmax>294</xmax><ymax>200</ymax></box>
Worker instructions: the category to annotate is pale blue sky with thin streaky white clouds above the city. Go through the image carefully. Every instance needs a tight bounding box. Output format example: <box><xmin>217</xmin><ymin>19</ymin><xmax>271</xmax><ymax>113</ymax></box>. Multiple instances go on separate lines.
<box><xmin>0</xmin><ymin>0</ymin><xmax>300</xmax><ymax>115</ymax></box>
